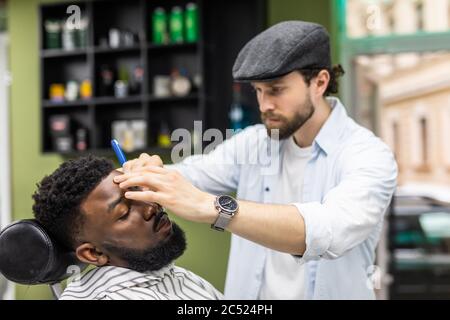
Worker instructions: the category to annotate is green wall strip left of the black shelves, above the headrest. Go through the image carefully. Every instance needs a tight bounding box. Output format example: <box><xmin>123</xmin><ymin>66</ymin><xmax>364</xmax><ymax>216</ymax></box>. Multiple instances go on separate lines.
<box><xmin>8</xmin><ymin>0</ymin><xmax>61</xmax><ymax>299</ymax></box>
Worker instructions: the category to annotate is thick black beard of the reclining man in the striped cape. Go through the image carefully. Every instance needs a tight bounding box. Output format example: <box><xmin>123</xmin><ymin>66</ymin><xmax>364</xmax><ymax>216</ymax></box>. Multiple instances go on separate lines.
<box><xmin>104</xmin><ymin>222</ymin><xmax>186</xmax><ymax>272</ymax></box>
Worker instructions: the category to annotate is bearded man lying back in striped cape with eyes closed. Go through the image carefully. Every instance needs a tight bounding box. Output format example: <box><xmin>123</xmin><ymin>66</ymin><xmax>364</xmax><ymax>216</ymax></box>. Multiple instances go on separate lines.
<box><xmin>33</xmin><ymin>156</ymin><xmax>223</xmax><ymax>300</ymax></box>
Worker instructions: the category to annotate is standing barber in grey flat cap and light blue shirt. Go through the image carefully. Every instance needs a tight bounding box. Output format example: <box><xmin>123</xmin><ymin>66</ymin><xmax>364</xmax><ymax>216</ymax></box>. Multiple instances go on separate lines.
<box><xmin>116</xmin><ymin>21</ymin><xmax>397</xmax><ymax>299</ymax></box>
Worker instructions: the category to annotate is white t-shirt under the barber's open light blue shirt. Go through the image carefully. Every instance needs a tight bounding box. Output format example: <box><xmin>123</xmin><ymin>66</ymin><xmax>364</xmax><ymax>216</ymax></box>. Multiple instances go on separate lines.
<box><xmin>259</xmin><ymin>137</ymin><xmax>312</xmax><ymax>300</ymax></box>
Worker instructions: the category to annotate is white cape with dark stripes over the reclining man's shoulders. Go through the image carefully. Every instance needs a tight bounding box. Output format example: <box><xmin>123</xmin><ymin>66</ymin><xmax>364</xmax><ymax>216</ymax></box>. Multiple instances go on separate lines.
<box><xmin>60</xmin><ymin>264</ymin><xmax>223</xmax><ymax>300</ymax></box>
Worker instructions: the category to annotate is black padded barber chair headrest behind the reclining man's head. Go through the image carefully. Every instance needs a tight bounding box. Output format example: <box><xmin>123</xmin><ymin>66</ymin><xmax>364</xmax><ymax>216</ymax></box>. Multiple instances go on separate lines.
<box><xmin>0</xmin><ymin>219</ymin><xmax>87</xmax><ymax>298</ymax></box>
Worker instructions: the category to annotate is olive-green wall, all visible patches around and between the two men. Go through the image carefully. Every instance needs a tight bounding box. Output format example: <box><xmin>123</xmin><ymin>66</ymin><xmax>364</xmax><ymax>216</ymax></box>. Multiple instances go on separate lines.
<box><xmin>8</xmin><ymin>0</ymin><xmax>336</xmax><ymax>299</ymax></box>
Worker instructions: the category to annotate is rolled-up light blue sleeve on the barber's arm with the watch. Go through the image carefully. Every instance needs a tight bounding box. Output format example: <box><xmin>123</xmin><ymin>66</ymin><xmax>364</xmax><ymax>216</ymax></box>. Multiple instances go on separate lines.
<box><xmin>294</xmin><ymin>142</ymin><xmax>397</xmax><ymax>262</ymax></box>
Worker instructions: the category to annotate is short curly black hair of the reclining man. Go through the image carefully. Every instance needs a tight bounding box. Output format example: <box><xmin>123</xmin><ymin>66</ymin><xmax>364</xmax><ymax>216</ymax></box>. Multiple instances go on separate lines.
<box><xmin>33</xmin><ymin>155</ymin><xmax>114</xmax><ymax>249</ymax></box>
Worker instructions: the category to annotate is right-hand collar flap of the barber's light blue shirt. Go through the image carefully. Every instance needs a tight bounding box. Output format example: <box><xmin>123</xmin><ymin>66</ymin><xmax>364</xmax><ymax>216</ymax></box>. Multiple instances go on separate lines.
<box><xmin>314</xmin><ymin>97</ymin><xmax>349</xmax><ymax>155</ymax></box>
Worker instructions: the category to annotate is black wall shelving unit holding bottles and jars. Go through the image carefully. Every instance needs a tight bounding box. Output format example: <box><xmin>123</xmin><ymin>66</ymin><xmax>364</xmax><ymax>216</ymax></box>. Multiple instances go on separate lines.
<box><xmin>39</xmin><ymin>0</ymin><xmax>266</xmax><ymax>155</ymax></box>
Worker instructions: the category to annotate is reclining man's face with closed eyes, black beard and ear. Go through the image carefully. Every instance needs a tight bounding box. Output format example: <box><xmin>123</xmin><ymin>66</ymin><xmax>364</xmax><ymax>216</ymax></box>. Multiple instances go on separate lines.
<box><xmin>76</xmin><ymin>170</ymin><xmax>186</xmax><ymax>272</ymax></box>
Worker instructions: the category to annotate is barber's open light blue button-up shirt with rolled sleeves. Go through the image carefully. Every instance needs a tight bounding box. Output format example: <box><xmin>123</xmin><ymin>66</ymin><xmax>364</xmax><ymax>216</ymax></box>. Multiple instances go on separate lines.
<box><xmin>173</xmin><ymin>98</ymin><xmax>397</xmax><ymax>299</ymax></box>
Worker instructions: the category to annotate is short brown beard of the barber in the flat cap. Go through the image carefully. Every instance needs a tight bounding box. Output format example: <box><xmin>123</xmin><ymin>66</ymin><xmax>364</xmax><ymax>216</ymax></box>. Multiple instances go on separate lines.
<box><xmin>261</xmin><ymin>96</ymin><xmax>315</xmax><ymax>140</ymax></box>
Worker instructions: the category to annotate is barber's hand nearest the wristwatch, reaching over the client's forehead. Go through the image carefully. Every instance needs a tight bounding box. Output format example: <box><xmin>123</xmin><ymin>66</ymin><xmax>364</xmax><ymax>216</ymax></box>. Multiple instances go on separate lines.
<box><xmin>114</xmin><ymin>165</ymin><xmax>217</xmax><ymax>223</ymax></box>
